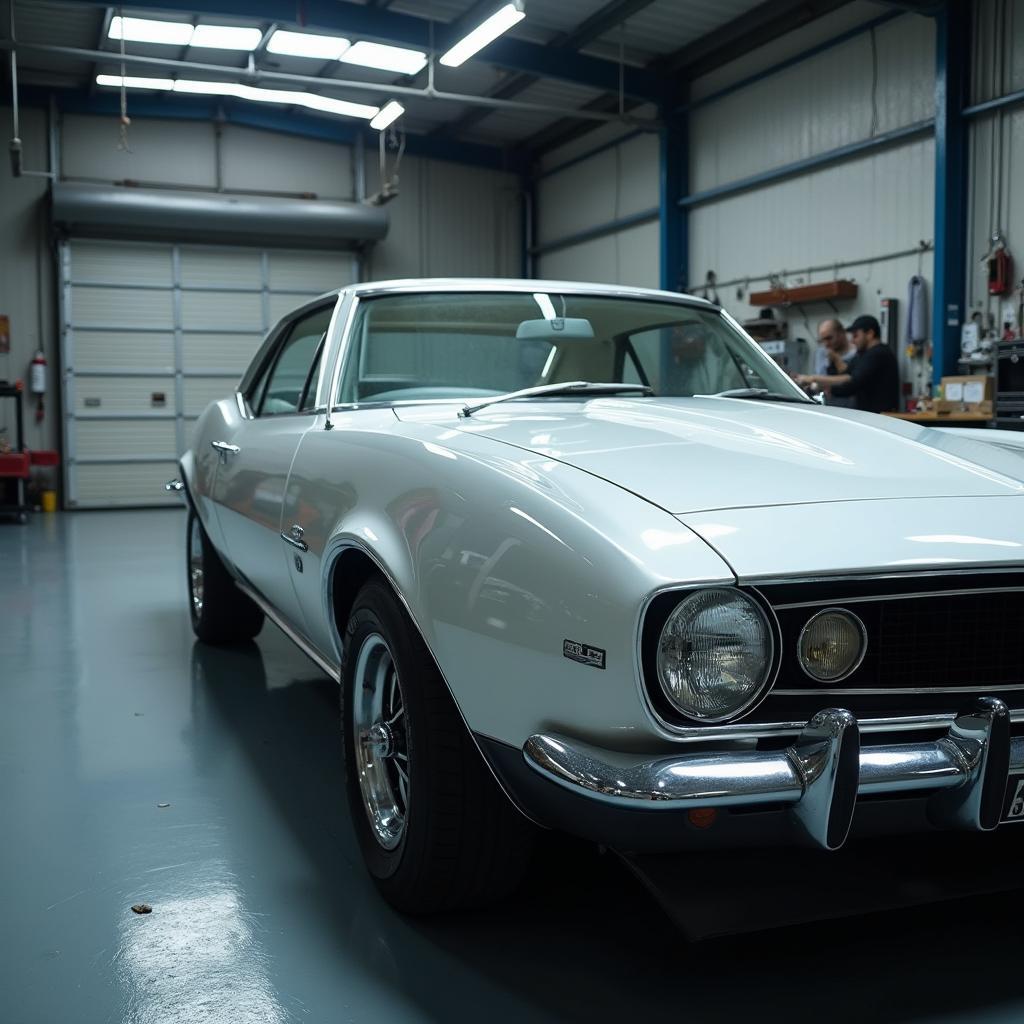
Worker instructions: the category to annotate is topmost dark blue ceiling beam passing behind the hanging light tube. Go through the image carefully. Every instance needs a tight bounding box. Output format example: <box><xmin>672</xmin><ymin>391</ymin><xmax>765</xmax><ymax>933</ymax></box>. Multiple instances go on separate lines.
<box><xmin>66</xmin><ymin>0</ymin><xmax>658</xmax><ymax>98</ymax></box>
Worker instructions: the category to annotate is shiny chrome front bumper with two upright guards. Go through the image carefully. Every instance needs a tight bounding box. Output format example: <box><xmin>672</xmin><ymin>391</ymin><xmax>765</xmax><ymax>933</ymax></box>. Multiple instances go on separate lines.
<box><xmin>523</xmin><ymin>697</ymin><xmax>1024</xmax><ymax>850</ymax></box>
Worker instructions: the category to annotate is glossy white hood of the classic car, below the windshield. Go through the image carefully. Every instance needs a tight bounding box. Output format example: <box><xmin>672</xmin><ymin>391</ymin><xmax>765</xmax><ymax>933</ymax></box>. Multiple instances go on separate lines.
<box><xmin>395</xmin><ymin>398</ymin><xmax>1024</xmax><ymax>516</ymax></box>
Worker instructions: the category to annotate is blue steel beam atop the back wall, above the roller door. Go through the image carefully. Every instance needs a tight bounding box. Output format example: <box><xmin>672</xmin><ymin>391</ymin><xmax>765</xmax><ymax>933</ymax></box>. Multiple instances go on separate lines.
<box><xmin>18</xmin><ymin>86</ymin><xmax>525</xmax><ymax>173</ymax></box>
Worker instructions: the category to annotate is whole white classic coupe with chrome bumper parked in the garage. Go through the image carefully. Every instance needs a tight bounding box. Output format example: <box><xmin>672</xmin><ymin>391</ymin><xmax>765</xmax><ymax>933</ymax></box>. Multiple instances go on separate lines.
<box><xmin>178</xmin><ymin>280</ymin><xmax>1024</xmax><ymax>912</ymax></box>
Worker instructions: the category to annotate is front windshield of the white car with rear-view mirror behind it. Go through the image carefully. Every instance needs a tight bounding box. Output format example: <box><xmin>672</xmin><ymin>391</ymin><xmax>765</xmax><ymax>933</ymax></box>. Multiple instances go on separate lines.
<box><xmin>335</xmin><ymin>292</ymin><xmax>800</xmax><ymax>404</ymax></box>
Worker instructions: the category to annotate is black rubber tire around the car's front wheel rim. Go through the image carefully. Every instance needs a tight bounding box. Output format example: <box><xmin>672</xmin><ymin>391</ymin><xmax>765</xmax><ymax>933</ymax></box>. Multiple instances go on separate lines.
<box><xmin>341</xmin><ymin>581</ymin><xmax>537</xmax><ymax>914</ymax></box>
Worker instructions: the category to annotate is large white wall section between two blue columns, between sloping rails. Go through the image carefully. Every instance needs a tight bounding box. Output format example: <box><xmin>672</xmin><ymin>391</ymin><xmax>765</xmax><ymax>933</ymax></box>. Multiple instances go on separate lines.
<box><xmin>690</xmin><ymin>15</ymin><xmax>935</xmax><ymax>191</ymax></box>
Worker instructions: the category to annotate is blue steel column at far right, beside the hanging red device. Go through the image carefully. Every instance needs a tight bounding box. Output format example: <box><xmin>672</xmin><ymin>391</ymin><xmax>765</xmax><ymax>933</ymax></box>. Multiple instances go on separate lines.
<box><xmin>932</xmin><ymin>0</ymin><xmax>972</xmax><ymax>383</ymax></box>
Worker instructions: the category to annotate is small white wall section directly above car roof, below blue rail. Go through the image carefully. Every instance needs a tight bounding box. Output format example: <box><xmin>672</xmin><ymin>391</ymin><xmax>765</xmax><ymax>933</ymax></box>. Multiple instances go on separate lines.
<box><xmin>537</xmin><ymin>221</ymin><xmax>658</xmax><ymax>288</ymax></box>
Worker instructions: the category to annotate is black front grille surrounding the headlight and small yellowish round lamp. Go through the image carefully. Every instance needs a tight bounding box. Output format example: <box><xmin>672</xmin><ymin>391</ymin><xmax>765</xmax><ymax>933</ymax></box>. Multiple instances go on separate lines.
<box><xmin>643</xmin><ymin>569</ymin><xmax>1024</xmax><ymax>728</ymax></box>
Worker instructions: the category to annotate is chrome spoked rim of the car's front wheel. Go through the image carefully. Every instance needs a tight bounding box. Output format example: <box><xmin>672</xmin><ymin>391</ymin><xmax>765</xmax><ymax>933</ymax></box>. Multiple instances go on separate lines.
<box><xmin>352</xmin><ymin>633</ymin><xmax>409</xmax><ymax>850</ymax></box>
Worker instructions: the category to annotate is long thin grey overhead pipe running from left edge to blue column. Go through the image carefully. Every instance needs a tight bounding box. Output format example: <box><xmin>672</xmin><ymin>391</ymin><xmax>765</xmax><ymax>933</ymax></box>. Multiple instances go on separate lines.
<box><xmin>0</xmin><ymin>40</ymin><xmax>660</xmax><ymax>131</ymax></box>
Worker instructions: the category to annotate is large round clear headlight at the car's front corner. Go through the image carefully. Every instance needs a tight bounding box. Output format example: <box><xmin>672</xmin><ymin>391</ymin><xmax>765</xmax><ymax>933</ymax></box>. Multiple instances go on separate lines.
<box><xmin>657</xmin><ymin>590</ymin><xmax>772</xmax><ymax>722</ymax></box>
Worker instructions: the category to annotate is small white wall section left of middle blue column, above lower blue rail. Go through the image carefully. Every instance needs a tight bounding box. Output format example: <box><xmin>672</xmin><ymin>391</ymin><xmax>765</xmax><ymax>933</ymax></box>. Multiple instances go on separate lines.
<box><xmin>537</xmin><ymin>135</ymin><xmax>658</xmax><ymax>243</ymax></box>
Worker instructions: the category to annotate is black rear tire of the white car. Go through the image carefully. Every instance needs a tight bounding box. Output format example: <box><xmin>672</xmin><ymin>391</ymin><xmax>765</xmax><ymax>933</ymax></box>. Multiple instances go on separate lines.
<box><xmin>185</xmin><ymin>509</ymin><xmax>263</xmax><ymax>645</ymax></box>
